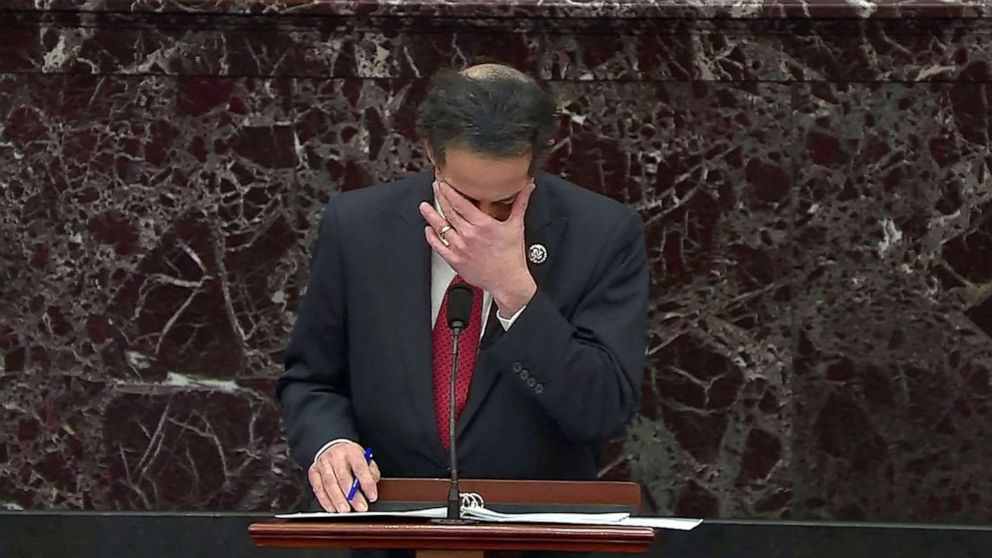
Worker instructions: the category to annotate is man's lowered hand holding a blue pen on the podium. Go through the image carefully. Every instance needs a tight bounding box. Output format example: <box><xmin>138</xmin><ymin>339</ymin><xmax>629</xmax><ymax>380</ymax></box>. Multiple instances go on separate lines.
<box><xmin>307</xmin><ymin>442</ymin><xmax>381</xmax><ymax>513</ymax></box>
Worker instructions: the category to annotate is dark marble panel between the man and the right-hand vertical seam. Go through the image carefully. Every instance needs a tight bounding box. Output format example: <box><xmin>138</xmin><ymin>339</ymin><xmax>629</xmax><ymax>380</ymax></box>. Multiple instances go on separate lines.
<box><xmin>550</xmin><ymin>82</ymin><xmax>793</xmax><ymax>516</ymax></box>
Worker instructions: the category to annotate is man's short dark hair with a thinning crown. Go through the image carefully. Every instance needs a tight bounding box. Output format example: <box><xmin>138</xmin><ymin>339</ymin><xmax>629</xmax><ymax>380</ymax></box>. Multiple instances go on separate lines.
<box><xmin>417</xmin><ymin>64</ymin><xmax>557</xmax><ymax>169</ymax></box>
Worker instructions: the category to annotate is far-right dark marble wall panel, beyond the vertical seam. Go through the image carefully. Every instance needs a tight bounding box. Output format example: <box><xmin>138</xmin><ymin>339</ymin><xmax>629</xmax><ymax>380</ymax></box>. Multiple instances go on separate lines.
<box><xmin>791</xmin><ymin>83</ymin><xmax>992</xmax><ymax>522</ymax></box>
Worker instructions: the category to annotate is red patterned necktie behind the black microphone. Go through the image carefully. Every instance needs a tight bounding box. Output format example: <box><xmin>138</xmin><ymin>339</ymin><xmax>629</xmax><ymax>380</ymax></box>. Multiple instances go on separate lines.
<box><xmin>431</xmin><ymin>275</ymin><xmax>482</xmax><ymax>449</ymax></box>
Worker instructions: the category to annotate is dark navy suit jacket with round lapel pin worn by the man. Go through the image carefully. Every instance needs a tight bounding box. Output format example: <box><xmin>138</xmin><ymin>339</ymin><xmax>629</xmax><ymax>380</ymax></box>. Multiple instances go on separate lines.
<box><xmin>277</xmin><ymin>173</ymin><xmax>648</xmax><ymax>486</ymax></box>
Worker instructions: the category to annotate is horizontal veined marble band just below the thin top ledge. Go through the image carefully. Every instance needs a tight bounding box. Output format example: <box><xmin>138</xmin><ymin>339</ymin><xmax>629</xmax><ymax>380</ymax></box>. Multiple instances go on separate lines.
<box><xmin>0</xmin><ymin>10</ymin><xmax>992</xmax><ymax>83</ymax></box>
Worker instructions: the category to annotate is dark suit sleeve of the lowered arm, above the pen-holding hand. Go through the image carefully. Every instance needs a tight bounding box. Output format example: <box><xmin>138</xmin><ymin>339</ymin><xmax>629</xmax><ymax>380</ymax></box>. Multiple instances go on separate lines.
<box><xmin>276</xmin><ymin>200</ymin><xmax>358</xmax><ymax>468</ymax></box>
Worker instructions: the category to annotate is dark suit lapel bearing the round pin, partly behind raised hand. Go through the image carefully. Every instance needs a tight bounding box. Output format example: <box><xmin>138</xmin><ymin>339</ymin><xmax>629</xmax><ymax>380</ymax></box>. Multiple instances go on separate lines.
<box><xmin>457</xmin><ymin>173</ymin><xmax>565</xmax><ymax>435</ymax></box>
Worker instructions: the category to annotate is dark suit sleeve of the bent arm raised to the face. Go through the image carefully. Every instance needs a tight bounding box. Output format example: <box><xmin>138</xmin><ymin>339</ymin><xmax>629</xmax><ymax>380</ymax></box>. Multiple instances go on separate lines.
<box><xmin>489</xmin><ymin>211</ymin><xmax>648</xmax><ymax>443</ymax></box>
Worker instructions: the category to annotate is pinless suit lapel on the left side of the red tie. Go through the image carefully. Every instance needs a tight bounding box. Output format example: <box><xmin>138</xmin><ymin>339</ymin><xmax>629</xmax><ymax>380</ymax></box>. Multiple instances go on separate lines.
<box><xmin>386</xmin><ymin>173</ymin><xmax>441</xmax><ymax>458</ymax></box>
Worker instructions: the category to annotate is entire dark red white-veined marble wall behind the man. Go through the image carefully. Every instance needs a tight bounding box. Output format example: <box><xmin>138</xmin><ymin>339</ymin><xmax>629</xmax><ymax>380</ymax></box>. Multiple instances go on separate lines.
<box><xmin>0</xmin><ymin>0</ymin><xmax>992</xmax><ymax>523</ymax></box>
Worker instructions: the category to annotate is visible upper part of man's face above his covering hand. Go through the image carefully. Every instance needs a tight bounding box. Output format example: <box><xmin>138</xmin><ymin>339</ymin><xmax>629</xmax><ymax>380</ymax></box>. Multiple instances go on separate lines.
<box><xmin>436</xmin><ymin>148</ymin><xmax>531</xmax><ymax>221</ymax></box>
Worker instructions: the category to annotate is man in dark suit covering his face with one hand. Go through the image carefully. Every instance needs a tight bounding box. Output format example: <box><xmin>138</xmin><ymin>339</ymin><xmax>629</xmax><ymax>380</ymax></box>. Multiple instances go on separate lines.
<box><xmin>277</xmin><ymin>64</ymin><xmax>648</xmax><ymax>512</ymax></box>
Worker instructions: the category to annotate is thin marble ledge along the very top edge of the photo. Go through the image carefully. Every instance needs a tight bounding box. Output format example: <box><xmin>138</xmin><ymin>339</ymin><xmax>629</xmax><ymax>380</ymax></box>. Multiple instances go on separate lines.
<box><xmin>0</xmin><ymin>0</ymin><xmax>992</xmax><ymax>19</ymax></box>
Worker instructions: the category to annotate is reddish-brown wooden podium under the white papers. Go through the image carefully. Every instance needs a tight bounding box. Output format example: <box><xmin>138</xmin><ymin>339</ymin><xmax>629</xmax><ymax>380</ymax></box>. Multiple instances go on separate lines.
<box><xmin>248</xmin><ymin>479</ymin><xmax>654</xmax><ymax>558</ymax></box>
